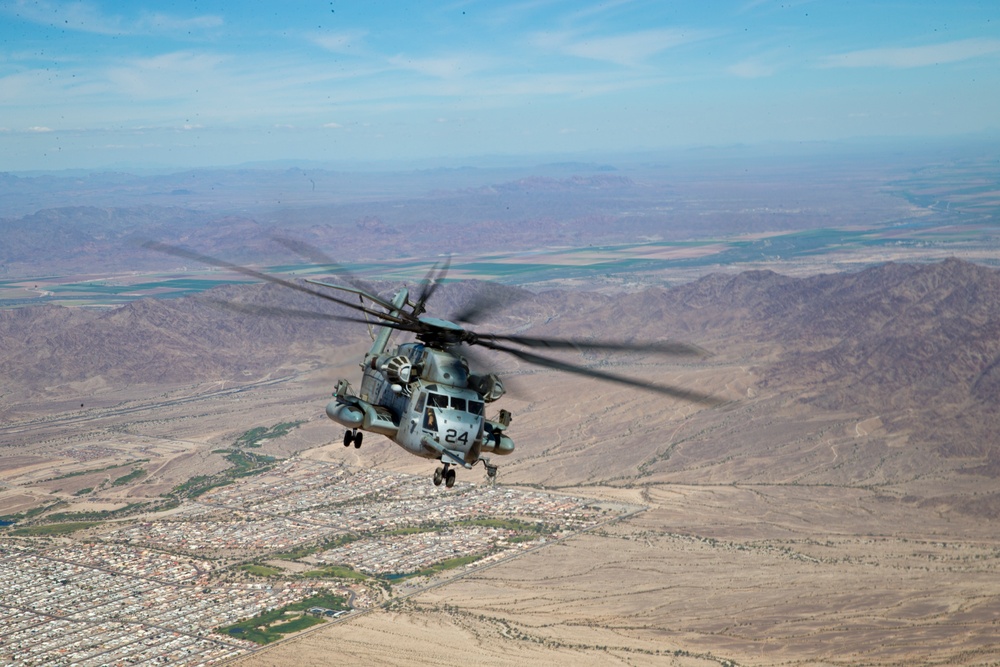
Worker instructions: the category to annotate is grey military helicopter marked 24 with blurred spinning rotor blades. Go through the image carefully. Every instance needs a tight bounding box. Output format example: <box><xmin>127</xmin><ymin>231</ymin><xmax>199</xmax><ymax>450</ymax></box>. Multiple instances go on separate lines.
<box><xmin>146</xmin><ymin>239</ymin><xmax>721</xmax><ymax>488</ymax></box>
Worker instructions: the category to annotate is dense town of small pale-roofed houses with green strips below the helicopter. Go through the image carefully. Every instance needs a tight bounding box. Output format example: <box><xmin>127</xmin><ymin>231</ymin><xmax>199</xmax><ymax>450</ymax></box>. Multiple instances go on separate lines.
<box><xmin>0</xmin><ymin>458</ymin><xmax>640</xmax><ymax>666</ymax></box>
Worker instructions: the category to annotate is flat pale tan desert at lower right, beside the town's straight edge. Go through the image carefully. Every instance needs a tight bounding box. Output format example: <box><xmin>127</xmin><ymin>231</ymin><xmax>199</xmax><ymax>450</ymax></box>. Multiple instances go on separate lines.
<box><xmin>237</xmin><ymin>485</ymin><xmax>1000</xmax><ymax>667</ymax></box>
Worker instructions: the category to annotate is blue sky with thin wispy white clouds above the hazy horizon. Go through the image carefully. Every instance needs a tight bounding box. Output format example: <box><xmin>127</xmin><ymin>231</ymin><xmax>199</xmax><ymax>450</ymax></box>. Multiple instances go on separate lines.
<box><xmin>0</xmin><ymin>0</ymin><xmax>1000</xmax><ymax>171</ymax></box>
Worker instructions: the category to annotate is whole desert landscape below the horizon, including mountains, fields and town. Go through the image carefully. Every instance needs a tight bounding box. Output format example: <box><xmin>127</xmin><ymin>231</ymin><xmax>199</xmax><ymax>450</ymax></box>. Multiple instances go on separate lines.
<box><xmin>0</xmin><ymin>150</ymin><xmax>1000</xmax><ymax>667</ymax></box>
